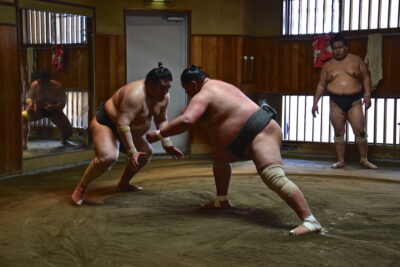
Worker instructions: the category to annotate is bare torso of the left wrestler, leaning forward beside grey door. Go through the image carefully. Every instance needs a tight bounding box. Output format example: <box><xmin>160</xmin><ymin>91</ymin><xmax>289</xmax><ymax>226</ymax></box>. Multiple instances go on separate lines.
<box><xmin>105</xmin><ymin>80</ymin><xmax>169</xmax><ymax>136</ymax></box>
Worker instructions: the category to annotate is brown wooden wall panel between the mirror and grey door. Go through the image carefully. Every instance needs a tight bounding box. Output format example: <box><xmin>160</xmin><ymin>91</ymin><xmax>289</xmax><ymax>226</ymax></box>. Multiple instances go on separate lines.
<box><xmin>94</xmin><ymin>34</ymin><xmax>126</xmax><ymax>107</ymax></box>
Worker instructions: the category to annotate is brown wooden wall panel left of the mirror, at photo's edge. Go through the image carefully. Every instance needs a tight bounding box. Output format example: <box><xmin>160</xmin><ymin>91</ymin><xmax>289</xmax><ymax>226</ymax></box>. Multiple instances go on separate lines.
<box><xmin>0</xmin><ymin>24</ymin><xmax>22</xmax><ymax>174</ymax></box>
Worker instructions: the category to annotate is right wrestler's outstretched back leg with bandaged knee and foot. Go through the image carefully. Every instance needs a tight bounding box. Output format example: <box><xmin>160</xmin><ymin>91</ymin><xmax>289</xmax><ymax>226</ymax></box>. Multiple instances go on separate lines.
<box><xmin>251</xmin><ymin>121</ymin><xmax>321</xmax><ymax>235</ymax></box>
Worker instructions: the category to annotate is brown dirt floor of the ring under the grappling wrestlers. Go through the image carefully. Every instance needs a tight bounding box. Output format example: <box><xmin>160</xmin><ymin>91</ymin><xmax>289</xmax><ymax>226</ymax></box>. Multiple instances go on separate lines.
<box><xmin>0</xmin><ymin>160</ymin><xmax>400</xmax><ymax>266</ymax></box>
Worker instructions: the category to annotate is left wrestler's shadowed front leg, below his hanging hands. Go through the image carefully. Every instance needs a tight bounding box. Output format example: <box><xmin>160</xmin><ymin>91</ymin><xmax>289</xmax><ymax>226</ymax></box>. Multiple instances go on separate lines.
<box><xmin>117</xmin><ymin>136</ymin><xmax>153</xmax><ymax>191</ymax></box>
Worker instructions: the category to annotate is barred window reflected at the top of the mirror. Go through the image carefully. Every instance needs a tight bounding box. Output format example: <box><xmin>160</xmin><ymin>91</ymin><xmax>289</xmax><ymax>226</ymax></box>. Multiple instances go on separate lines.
<box><xmin>21</xmin><ymin>9</ymin><xmax>87</xmax><ymax>45</ymax></box>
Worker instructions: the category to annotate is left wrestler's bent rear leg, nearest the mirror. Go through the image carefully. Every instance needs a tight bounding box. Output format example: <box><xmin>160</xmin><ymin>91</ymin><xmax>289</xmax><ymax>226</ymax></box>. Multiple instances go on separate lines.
<box><xmin>71</xmin><ymin>117</ymin><xmax>119</xmax><ymax>206</ymax></box>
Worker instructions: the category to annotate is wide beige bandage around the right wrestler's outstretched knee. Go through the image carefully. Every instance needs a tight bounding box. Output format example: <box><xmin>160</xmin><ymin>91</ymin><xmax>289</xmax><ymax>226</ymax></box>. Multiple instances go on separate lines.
<box><xmin>261</xmin><ymin>164</ymin><xmax>299</xmax><ymax>199</ymax></box>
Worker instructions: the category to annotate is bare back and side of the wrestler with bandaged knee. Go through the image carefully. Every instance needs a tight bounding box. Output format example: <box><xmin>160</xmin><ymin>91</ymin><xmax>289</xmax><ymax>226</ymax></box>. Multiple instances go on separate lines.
<box><xmin>192</xmin><ymin>80</ymin><xmax>259</xmax><ymax>147</ymax></box>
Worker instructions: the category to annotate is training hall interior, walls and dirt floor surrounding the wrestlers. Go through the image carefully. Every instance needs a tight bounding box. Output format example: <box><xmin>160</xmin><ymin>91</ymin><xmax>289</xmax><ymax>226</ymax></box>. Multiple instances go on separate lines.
<box><xmin>0</xmin><ymin>0</ymin><xmax>400</xmax><ymax>266</ymax></box>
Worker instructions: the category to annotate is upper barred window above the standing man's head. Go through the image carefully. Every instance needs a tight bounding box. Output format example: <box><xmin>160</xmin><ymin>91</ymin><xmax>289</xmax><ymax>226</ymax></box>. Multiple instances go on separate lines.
<box><xmin>282</xmin><ymin>0</ymin><xmax>400</xmax><ymax>35</ymax></box>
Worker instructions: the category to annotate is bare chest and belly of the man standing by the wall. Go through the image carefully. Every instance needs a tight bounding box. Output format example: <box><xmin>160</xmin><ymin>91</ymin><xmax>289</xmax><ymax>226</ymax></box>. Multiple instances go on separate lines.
<box><xmin>324</xmin><ymin>53</ymin><xmax>364</xmax><ymax>95</ymax></box>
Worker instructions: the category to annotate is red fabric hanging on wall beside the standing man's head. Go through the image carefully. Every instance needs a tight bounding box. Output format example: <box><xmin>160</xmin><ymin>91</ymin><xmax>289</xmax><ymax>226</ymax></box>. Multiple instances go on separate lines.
<box><xmin>312</xmin><ymin>33</ymin><xmax>333</xmax><ymax>68</ymax></box>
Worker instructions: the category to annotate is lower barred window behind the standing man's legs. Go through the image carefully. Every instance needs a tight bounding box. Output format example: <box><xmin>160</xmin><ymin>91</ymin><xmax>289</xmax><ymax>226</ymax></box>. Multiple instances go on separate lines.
<box><xmin>282</xmin><ymin>95</ymin><xmax>400</xmax><ymax>145</ymax></box>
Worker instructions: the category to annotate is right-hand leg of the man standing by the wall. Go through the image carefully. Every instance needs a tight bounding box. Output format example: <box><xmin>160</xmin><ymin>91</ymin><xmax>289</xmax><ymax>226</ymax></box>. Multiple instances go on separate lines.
<box><xmin>347</xmin><ymin>101</ymin><xmax>378</xmax><ymax>169</ymax></box>
